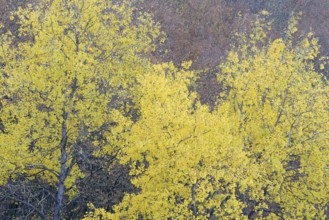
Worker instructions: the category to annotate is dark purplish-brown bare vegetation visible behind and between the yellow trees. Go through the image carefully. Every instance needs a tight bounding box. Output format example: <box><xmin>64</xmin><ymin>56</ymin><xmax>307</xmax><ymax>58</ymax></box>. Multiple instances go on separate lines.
<box><xmin>0</xmin><ymin>0</ymin><xmax>329</xmax><ymax>219</ymax></box>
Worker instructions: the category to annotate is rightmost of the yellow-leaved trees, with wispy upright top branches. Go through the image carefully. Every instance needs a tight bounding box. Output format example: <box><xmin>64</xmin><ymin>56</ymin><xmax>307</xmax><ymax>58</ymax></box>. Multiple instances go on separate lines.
<box><xmin>215</xmin><ymin>19</ymin><xmax>329</xmax><ymax>218</ymax></box>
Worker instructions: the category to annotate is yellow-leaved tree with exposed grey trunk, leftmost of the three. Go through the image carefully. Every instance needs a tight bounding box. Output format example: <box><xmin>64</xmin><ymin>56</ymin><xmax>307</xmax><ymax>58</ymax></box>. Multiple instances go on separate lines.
<box><xmin>0</xmin><ymin>0</ymin><xmax>159</xmax><ymax>219</ymax></box>
